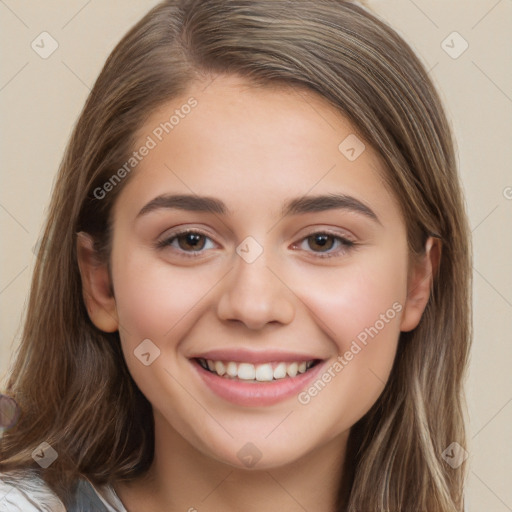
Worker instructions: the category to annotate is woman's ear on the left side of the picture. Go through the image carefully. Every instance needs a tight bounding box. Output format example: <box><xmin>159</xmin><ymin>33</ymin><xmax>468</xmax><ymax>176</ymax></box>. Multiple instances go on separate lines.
<box><xmin>76</xmin><ymin>231</ymin><xmax>119</xmax><ymax>332</ymax></box>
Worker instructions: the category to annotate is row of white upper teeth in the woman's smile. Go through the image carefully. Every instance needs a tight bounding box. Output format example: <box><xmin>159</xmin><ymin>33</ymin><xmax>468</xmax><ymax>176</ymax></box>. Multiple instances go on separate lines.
<box><xmin>199</xmin><ymin>359</ymin><xmax>314</xmax><ymax>382</ymax></box>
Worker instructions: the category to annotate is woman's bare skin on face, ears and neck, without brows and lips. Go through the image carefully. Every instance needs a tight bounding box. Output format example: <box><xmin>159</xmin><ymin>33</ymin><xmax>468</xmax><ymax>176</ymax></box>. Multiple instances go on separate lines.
<box><xmin>78</xmin><ymin>76</ymin><xmax>439</xmax><ymax>512</ymax></box>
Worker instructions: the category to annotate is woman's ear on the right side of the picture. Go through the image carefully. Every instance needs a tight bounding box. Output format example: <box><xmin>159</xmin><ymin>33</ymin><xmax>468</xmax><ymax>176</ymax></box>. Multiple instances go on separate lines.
<box><xmin>400</xmin><ymin>236</ymin><xmax>441</xmax><ymax>332</ymax></box>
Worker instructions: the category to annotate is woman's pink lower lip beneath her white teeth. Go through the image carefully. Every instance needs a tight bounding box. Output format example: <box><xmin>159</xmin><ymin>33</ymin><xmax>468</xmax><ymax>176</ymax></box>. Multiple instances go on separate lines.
<box><xmin>192</xmin><ymin>360</ymin><xmax>323</xmax><ymax>407</ymax></box>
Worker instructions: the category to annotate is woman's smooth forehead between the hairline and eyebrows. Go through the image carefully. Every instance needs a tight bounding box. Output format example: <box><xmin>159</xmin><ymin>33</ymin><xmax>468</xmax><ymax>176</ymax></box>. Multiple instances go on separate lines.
<box><xmin>114</xmin><ymin>76</ymin><xmax>396</xmax><ymax>224</ymax></box>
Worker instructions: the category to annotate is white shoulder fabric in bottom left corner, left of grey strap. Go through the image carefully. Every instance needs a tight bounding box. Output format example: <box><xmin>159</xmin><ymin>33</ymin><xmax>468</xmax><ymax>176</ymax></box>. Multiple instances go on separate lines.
<box><xmin>0</xmin><ymin>470</ymin><xmax>66</xmax><ymax>512</ymax></box>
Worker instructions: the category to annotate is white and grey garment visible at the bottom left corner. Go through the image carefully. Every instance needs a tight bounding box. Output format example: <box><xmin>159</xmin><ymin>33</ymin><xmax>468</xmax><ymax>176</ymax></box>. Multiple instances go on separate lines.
<box><xmin>0</xmin><ymin>470</ymin><xmax>127</xmax><ymax>512</ymax></box>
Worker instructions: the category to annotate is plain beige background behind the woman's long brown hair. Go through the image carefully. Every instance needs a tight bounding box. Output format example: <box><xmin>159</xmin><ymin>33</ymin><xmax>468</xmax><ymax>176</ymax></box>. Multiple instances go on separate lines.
<box><xmin>0</xmin><ymin>0</ymin><xmax>512</xmax><ymax>512</ymax></box>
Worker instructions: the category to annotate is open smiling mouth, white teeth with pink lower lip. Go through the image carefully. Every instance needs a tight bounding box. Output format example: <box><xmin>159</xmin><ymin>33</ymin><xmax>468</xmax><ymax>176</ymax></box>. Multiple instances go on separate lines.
<box><xmin>190</xmin><ymin>354</ymin><xmax>327</xmax><ymax>407</ymax></box>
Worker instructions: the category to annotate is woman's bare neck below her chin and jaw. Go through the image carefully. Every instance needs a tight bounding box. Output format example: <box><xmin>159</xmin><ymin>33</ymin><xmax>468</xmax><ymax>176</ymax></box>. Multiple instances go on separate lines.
<box><xmin>115</xmin><ymin>413</ymin><xmax>348</xmax><ymax>512</ymax></box>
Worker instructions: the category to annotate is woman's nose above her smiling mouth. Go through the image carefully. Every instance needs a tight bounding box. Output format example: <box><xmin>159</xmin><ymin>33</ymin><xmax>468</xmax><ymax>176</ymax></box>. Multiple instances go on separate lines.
<box><xmin>217</xmin><ymin>251</ymin><xmax>295</xmax><ymax>330</ymax></box>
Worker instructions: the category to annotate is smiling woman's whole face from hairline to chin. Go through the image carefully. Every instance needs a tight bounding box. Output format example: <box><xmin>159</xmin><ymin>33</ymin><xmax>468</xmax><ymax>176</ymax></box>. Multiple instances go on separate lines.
<box><xmin>79</xmin><ymin>77</ymin><xmax>432</xmax><ymax>468</ymax></box>
